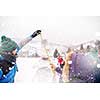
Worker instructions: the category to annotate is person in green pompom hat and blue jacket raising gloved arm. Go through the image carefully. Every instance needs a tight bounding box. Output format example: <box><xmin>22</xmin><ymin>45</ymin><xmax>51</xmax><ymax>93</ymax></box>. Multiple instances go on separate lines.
<box><xmin>0</xmin><ymin>30</ymin><xmax>41</xmax><ymax>83</ymax></box>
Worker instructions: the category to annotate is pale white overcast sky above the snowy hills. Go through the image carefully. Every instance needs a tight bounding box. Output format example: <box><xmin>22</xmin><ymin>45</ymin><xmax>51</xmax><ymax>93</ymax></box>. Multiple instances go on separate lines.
<box><xmin>0</xmin><ymin>16</ymin><xmax>100</xmax><ymax>44</ymax></box>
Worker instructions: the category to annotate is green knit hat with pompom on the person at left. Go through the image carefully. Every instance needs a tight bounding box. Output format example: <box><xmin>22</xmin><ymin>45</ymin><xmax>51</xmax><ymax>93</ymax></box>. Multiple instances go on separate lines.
<box><xmin>0</xmin><ymin>36</ymin><xmax>18</xmax><ymax>54</ymax></box>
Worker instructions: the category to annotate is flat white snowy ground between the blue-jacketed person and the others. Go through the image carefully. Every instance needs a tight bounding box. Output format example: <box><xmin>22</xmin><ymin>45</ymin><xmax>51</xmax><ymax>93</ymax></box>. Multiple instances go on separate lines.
<box><xmin>15</xmin><ymin>57</ymin><xmax>55</xmax><ymax>83</ymax></box>
